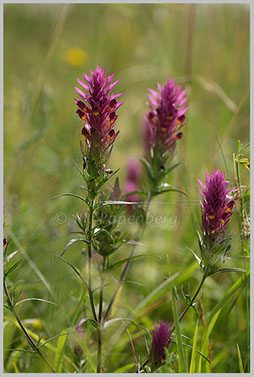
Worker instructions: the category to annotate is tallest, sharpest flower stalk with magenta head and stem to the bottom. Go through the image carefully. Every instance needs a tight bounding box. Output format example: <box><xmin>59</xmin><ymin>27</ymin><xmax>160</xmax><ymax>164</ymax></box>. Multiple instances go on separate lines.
<box><xmin>75</xmin><ymin>66</ymin><xmax>124</xmax><ymax>373</ymax></box>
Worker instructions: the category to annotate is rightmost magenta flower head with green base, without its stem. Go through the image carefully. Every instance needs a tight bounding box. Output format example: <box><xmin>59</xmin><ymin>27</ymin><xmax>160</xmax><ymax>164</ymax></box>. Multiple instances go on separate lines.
<box><xmin>198</xmin><ymin>170</ymin><xmax>235</xmax><ymax>274</ymax></box>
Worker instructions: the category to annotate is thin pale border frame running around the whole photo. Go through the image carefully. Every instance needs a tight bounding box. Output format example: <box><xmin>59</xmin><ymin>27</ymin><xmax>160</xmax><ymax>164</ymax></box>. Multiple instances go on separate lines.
<box><xmin>0</xmin><ymin>0</ymin><xmax>254</xmax><ymax>376</ymax></box>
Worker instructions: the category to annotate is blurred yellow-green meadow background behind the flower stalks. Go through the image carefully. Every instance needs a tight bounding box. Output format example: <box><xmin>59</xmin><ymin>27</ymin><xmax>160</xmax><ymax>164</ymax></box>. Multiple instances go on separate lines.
<box><xmin>4</xmin><ymin>4</ymin><xmax>250</xmax><ymax>373</ymax></box>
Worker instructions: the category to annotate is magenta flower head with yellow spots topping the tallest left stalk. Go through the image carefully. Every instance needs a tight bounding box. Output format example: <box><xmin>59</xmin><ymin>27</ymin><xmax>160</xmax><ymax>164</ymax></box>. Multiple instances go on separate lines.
<box><xmin>75</xmin><ymin>66</ymin><xmax>124</xmax><ymax>178</ymax></box>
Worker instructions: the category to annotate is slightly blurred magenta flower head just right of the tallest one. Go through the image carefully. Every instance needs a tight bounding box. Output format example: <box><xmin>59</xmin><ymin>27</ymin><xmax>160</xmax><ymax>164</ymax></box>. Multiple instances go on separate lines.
<box><xmin>144</xmin><ymin>79</ymin><xmax>188</xmax><ymax>163</ymax></box>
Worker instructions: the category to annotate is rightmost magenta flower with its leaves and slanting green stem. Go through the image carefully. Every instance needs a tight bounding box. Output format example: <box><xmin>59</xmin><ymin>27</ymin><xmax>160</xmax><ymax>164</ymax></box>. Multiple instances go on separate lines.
<box><xmin>172</xmin><ymin>170</ymin><xmax>240</xmax><ymax>331</ymax></box>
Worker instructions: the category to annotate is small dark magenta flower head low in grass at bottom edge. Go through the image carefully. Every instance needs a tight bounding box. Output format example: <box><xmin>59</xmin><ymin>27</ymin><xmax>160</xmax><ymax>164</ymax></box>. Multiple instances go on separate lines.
<box><xmin>150</xmin><ymin>321</ymin><xmax>171</xmax><ymax>369</ymax></box>
